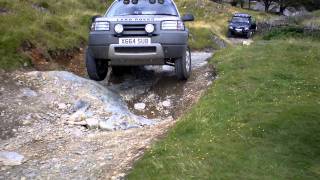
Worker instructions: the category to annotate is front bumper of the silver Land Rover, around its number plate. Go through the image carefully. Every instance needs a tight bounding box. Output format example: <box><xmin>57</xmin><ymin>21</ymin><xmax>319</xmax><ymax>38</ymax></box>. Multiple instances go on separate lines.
<box><xmin>88</xmin><ymin>31</ymin><xmax>188</xmax><ymax>66</ymax></box>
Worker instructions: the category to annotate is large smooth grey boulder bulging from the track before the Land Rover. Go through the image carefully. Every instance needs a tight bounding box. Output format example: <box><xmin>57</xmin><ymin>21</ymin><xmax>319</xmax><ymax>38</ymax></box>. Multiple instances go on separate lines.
<box><xmin>24</xmin><ymin>71</ymin><xmax>154</xmax><ymax>130</ymax></box>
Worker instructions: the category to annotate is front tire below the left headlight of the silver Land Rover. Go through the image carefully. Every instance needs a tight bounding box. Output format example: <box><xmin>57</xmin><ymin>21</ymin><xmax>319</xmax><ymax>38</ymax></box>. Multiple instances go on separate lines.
<box><xmin>85</xmin><ymin>49</ymin><xmax>108</xmax><ymax>81</ymax></box>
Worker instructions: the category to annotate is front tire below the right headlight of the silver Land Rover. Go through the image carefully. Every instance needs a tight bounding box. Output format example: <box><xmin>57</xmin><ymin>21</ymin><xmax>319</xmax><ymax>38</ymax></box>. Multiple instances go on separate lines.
<box><xmin>175</xmin><ymin>47</ymin><xmax>191</xmax><ymax>80</ymax></box>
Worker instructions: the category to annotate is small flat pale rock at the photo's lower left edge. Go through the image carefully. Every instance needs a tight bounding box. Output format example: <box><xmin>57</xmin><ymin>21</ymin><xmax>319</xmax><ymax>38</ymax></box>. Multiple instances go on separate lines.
<box><xmin>0</xmin><ymin>151</ymin><xmax>24</xmax><ymax>166</ymax></box>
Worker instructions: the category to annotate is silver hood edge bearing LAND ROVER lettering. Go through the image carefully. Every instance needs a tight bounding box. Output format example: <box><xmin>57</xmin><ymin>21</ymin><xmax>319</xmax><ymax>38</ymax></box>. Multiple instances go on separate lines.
<box><xmin>96</xmin><ymin>15</ymin><xmax>180</xmax><ymax>22</ymax></box>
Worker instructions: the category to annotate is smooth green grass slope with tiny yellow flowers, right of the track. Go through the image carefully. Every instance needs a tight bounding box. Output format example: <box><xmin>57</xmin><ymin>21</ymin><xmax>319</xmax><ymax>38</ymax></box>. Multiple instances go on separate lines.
<box><xmin>128</xmin><ymin>38</ymin><xmax>320</xmax><ymax>180</ymax></box>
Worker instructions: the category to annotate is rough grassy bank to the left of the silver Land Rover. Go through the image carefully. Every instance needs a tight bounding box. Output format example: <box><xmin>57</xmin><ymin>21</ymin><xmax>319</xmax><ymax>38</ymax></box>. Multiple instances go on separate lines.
<box><xmin>0</xmin><ymin>0</ymin><xmax>109</xmax><ymax>69</ymax></box>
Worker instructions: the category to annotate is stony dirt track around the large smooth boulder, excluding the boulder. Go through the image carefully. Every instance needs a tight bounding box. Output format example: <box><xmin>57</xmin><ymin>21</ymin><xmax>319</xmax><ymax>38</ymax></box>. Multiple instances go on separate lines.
<box><xmin>0</xmin><ymin>52</ymin><xmax>215</xmax><ymax>179</ymax></box>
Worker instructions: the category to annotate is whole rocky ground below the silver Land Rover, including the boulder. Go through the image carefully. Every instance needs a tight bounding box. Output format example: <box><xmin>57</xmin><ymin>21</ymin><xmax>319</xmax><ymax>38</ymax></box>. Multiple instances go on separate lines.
<box><xmin>0</xmin><ymin>52</ymin><xmax>215</xmax><ymax>179</ymax></box>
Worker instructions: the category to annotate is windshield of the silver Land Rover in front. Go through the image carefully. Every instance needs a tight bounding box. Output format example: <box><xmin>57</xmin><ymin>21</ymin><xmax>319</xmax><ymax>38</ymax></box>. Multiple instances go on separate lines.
<box><xmin>106</xmin><ymin>0</ymin><xmax>178</xmax><ymax>17</ymax></box>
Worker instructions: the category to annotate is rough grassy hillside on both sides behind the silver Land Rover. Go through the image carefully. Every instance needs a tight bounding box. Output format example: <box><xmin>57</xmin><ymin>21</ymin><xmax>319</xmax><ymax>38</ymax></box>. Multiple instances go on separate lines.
<box><xmin>0</xmin><ymin>0</ymin><xmax>268</xmax><ymax>69</ymax></box>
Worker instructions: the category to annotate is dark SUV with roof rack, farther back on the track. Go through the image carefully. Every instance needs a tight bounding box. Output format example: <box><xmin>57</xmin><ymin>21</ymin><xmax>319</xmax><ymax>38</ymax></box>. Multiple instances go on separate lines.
<box><xmin>228</xmin><ymin>13</ymin><xmax>257</xmax><ymax>38</ymax></box>
